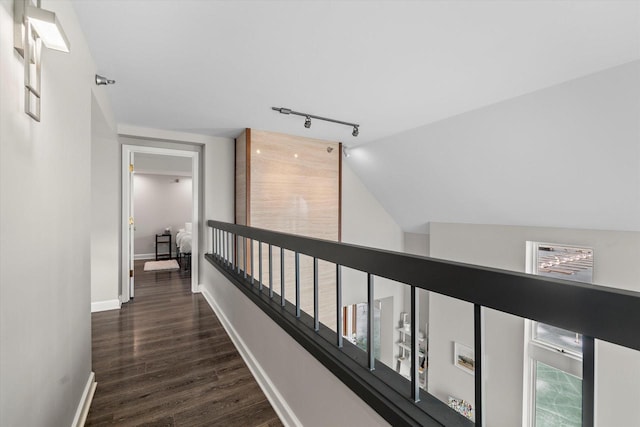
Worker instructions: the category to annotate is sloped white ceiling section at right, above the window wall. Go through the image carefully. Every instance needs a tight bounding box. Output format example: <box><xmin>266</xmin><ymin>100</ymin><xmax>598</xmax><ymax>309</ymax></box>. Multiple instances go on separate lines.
<box><xmin>349</xmin><ymin>61</ymin><xmax>640</xmax><ymax>233</ymax></box>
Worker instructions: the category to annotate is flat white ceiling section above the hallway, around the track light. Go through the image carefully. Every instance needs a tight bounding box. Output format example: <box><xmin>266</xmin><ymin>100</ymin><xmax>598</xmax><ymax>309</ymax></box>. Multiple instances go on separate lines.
<box><xmin>74</xmin><ymin>0</ymin><xmax>640</xmax><ymax>145</ymax></box>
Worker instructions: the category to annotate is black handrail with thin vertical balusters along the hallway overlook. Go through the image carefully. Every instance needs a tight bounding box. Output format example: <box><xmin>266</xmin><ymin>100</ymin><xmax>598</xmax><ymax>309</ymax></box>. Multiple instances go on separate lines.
<box><xmin>207</xmin><ymin>220</ymin><xmax>640</xmax><ymax>425</ymax></box>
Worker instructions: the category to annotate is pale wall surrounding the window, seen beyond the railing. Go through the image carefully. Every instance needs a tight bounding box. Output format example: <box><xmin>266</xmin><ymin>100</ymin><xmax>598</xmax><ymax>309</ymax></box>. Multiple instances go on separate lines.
<box><xmin>429</xmin><ymin>223</ymin><xmax>640</xmax><ymax>427</ymax></box>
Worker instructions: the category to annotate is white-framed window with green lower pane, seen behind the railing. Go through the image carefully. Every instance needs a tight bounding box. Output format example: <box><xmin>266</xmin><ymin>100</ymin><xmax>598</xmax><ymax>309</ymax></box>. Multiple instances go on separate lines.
<box><xmin>525</xmin><ymin>242</ymin><xmax>593</xmax><ymax>427</ymax></box>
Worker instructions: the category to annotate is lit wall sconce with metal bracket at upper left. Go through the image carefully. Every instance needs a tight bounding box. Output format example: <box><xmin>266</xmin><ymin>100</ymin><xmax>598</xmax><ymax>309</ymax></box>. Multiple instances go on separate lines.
<box><xmin>13</xmin><ymin>0</ymin><xmax>70</xmax><ymax>122</ymax></box>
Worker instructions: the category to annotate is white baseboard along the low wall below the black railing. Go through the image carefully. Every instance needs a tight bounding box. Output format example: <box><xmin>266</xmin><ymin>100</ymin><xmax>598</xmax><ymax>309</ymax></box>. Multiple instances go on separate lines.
<box><xmin>199</xmin><ymin>285</ymin><xmax>302</xmax><ymax>427</ymax></box>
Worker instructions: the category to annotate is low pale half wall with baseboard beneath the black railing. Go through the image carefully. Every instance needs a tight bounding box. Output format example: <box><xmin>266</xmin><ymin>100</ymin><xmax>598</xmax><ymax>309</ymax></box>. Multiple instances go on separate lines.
<box><xmin>202</xmin><ymin>262</ymin><xmax>388</xmax><ymax>427</ymax></box>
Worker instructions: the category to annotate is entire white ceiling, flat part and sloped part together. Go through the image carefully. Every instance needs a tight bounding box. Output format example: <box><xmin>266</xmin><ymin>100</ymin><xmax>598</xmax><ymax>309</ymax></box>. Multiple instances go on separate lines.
<box><xmin>74</xmin><ymin>0</ymin><xmax>640</xmax><ymax>232</ymax></box>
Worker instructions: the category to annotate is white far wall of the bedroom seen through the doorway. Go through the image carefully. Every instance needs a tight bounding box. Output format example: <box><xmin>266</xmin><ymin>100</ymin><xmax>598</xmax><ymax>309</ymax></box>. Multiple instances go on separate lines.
<box><xmin>133</xmin><ymin>173</ymin><xmax>193</xmax><ymax>258</ymax></box>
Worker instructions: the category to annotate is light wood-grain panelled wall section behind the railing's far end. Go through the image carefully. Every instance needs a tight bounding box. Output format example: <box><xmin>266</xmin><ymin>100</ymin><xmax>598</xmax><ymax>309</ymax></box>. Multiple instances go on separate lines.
<box><xmin>235</xmin><ymin>129</ymin><xmax>342</xmax><ymax>330</ymax></box>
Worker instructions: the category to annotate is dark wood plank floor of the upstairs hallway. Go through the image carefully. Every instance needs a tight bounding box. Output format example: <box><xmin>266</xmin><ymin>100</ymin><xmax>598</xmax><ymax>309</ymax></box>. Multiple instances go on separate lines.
<box><xmin>86</xmin><ymin>261</ymin><xmax>282</xmax><ymax>426</ymax></box>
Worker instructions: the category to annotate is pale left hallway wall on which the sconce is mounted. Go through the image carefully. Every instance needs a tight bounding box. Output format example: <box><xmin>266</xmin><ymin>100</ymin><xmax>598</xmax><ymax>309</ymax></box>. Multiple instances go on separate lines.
<box><xmin>0</xmin><ymin>0</ymin><xmax>110</xmax><ymax>426</ymax></box>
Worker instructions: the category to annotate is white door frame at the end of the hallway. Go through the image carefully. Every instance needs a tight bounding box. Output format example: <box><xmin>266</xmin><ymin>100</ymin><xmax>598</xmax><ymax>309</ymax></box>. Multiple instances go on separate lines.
<box><xmin>121</xmin><ymin>144</ymin><xmax>201</xmax><ymax>303</ymax></box>
